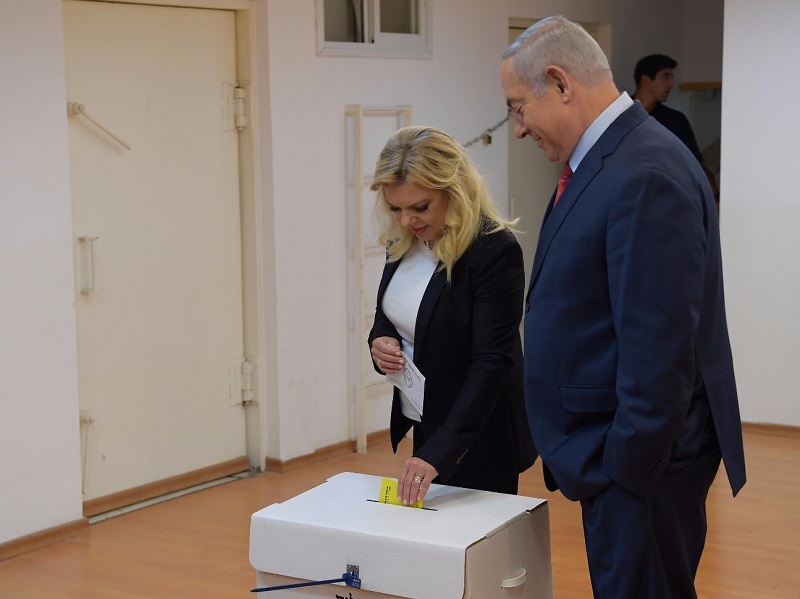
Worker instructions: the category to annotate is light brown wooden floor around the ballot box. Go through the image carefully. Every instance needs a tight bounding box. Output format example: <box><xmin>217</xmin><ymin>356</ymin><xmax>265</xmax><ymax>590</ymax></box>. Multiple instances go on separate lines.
<box><xmin>0</xmin><ymin>432</ymin><xmax>800</xmax><ymax>599</ymax></box>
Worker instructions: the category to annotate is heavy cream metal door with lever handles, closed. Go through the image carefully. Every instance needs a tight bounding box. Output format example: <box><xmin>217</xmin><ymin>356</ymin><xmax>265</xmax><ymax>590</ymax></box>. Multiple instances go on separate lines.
<box><xmin>64</xmin><ymin>1</ymin><xmax>246</xmax><ymax>500</ymax></box>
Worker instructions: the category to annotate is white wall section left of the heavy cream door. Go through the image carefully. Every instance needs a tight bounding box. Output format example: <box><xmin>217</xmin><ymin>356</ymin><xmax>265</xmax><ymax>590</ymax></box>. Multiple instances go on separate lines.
<box><xmin>0</xmin><ymin>0</ymin><xmax>82</xmax><ymax>543</ymax></box>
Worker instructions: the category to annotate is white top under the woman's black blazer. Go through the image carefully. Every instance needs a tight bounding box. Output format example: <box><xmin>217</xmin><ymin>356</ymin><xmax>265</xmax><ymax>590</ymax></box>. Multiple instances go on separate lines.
<box><xmin>382</xmin><ymin>239</ymin><xmax>439</xmax><ymax>422</ymax></box>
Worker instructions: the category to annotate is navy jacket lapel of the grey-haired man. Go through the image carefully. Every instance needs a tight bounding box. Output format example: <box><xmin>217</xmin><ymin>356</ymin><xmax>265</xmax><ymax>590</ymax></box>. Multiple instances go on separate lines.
<box><xmin>528</xmin><ymin>102</ymin><xmax>649</xmax><ymax>295</ymax></box>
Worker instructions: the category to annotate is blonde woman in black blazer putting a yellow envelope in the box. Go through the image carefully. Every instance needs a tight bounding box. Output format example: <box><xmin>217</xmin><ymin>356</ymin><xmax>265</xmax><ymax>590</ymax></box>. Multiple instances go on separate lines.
<box><xmin>369</xmin><ymin>127</ymin><xmax>536</xmax><ymax>504</ymax></box>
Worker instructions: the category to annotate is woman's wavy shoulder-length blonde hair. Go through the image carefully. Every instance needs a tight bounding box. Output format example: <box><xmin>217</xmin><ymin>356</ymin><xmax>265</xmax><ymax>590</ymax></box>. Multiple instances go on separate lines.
<box><xmin>370</xmin><ymin>126</ymin><xmax>518</xmax><ymax>281</ymax></box>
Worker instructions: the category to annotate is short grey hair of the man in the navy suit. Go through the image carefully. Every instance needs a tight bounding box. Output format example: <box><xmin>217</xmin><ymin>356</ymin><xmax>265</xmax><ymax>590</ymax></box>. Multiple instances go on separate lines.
<box><xmin>503</xmin><ymin>16</ymin><xmax>613</xmax><ymax>96</ymax></box>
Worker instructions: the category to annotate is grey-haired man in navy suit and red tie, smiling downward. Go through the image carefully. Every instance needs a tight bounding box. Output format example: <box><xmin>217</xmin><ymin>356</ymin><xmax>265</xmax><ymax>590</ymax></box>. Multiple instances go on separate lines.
<box><xmin>501</xmin><ymin>17</ymin><xmax>745</xmax><ymax>599</ymax></box>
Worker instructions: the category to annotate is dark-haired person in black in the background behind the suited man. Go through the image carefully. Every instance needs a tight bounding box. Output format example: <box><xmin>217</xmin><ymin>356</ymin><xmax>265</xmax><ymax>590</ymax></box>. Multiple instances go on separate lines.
<box><xmin>633</xmin><ymin>54</ymin><xmax>719</xmax><ymax>208</ymax></box>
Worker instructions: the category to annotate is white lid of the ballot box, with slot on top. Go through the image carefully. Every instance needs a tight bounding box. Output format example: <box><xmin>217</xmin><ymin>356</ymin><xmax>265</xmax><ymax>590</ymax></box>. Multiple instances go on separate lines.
<box><xmin>250</xmin><ymin>472</ymin><xmax>544</xmax><ymax>599</ymax></box>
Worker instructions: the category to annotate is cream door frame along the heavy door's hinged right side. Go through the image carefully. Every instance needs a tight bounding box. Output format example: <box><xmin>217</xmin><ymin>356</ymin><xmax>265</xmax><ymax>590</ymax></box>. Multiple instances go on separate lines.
<box><xmin>71</xmin><ymin>0</ymin><xmax>279</xmax><ymax>472</ymax></box>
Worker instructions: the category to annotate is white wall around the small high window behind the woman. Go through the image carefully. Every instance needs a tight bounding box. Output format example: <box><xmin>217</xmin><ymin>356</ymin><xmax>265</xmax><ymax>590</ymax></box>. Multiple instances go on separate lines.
<box><xmin>260</xmin><ymin>0</ymin><xmax>683</xmax><ymax>459</ymax></box>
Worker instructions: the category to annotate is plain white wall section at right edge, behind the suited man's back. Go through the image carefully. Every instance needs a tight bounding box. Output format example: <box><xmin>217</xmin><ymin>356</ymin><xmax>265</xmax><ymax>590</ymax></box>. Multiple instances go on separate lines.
<box><xmin>720</xmin><ymin>0</ymin><xmax>800</xmax><ymax>426</ymax></box>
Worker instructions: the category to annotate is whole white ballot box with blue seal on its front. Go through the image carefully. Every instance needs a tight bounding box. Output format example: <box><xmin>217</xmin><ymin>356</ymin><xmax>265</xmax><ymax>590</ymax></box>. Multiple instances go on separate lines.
<box><xmin>250</xmin><ymin>472</ymin><xmax>552</xmax><ymax>599</ymax></box>
